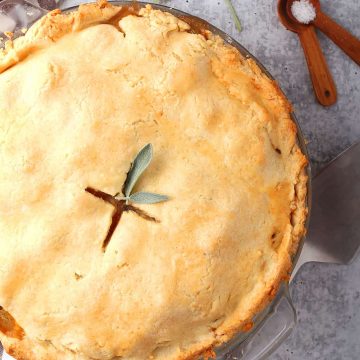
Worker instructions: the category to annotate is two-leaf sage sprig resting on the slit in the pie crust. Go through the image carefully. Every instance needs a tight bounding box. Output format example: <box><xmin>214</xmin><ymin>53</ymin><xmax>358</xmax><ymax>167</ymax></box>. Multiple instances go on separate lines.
<box><xmin>115</xmin><ymin>144</ymin><xmax>169</xmax><ymax>204</ymax></box>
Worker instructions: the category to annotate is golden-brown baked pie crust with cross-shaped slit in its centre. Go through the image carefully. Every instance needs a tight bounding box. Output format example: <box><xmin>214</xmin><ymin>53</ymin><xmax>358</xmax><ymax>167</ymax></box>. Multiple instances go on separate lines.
<box><xmin>0</xmin><ymin>2</ymin><xmax>307</xmax><ymax>360</ymax></box>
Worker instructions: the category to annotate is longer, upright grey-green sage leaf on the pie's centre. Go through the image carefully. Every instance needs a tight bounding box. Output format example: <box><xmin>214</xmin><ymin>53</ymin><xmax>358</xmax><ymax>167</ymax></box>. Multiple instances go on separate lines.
<box><xmin>122</xmin><ymin>144</ymin><xmax>153</xmax><ymax>197</ymax></box>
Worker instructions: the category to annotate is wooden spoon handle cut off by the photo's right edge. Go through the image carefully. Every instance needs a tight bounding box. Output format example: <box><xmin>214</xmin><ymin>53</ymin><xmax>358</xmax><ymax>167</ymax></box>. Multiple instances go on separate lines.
<box><xmin>314</xmin><ymin>11</ymin><xmax>360</xmax><ymax>65</ymax></box>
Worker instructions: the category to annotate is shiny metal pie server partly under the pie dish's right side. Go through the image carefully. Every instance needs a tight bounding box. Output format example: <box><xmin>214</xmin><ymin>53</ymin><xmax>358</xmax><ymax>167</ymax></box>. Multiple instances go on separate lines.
<box><xmin>292</xmin><ymin>142</ymin><xmax>360</xmax><ymax>278</ymax></box>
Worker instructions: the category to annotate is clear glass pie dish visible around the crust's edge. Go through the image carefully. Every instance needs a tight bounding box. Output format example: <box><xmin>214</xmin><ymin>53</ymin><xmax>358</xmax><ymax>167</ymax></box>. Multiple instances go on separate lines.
<box><xmin>0</xmin><ymin>0</ymin><xmax>311</xmax><ymax>359</ymax></box>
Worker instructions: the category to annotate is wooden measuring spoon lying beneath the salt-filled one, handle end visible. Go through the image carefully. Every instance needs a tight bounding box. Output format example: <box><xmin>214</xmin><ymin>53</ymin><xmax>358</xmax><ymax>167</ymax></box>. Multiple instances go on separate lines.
<box><xmin>278</xmin><ymin>0</ymin><xmax>337</xmax><ymax>106</ymax></box>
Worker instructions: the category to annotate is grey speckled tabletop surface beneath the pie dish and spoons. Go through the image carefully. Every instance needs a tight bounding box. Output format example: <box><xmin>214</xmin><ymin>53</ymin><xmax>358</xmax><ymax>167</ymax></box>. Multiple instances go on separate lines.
<box><xmin>143</xmin><ymin>0</ymin><xmax>360</xmax><ymax>360</ymax></box>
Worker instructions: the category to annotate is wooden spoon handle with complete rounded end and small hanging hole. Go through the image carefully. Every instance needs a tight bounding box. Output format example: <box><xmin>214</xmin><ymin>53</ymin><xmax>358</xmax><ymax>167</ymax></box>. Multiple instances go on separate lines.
<box><xmin>298</xmin><ymin>25</ymin><xmax>337</xmax><ymax>106</ymax></box>
